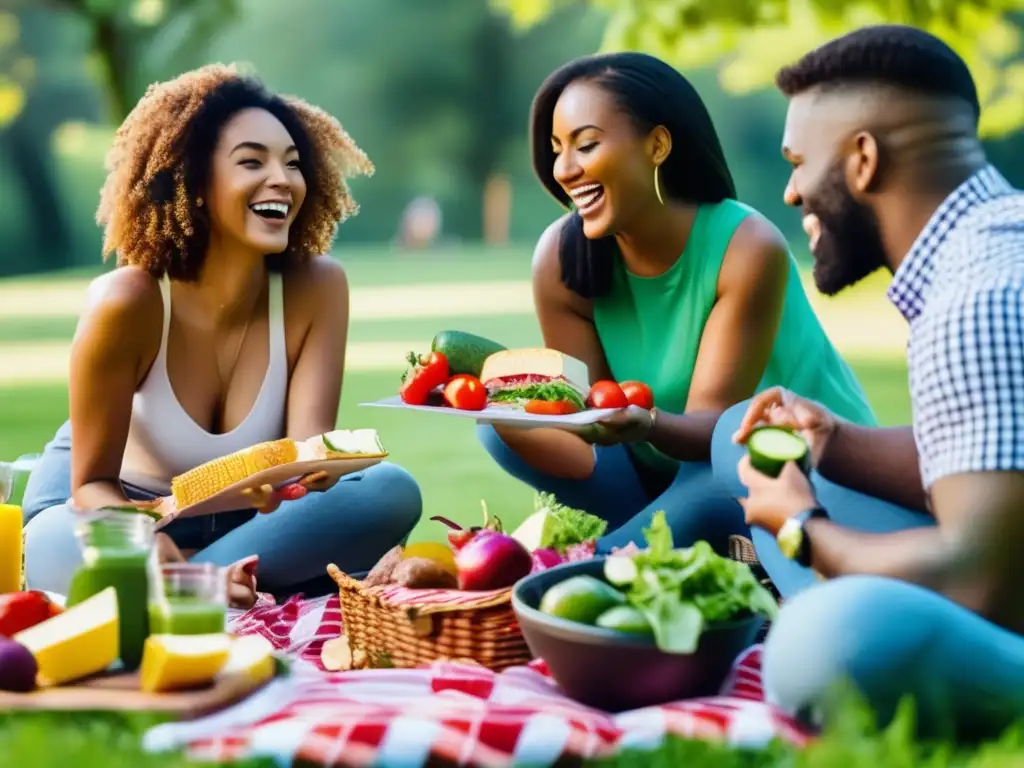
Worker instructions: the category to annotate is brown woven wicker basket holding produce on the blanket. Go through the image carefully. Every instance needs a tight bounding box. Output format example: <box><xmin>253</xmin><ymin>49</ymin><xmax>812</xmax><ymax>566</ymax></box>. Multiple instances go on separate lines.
<box><xmin>328</xmin><ymin>564</ymin><xmax>532</xmax><ymax>672</ymax></box>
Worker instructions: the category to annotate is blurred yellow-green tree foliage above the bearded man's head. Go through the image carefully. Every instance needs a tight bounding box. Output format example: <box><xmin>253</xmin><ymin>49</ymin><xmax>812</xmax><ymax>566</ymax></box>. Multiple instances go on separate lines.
<box><xmin>492</xmin><ymin>0</ymin><xmax>1024</xmax><ymax>137</ymax></box>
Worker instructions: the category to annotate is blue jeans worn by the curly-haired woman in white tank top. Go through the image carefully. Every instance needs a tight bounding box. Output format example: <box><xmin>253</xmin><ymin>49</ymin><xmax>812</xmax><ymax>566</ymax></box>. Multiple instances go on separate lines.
<box><xmin>23</xmin><ymin>423</ymin><xmax>423</xmax><ymax>597</ymax></box>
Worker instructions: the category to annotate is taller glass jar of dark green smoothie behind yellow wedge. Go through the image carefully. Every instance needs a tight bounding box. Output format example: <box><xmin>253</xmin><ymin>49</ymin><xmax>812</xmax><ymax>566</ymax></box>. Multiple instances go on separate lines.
<box><xmin>68</xmin><ymin>512</ymin><xmax>157</xmax><ymax>672</ymax></box>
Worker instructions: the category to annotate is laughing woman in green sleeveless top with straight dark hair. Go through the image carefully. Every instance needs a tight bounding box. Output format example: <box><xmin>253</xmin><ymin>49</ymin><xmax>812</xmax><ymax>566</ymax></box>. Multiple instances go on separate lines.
<box><xmin>478</xmin><ymin>53</ymin><xmax>874</xmax><ymax>551</ymax></box>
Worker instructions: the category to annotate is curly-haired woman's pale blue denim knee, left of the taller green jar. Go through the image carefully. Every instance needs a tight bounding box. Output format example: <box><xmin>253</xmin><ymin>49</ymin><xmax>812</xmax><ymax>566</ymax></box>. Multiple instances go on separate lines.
<box><xmin>25</xmin><ymin>504</ymin><xmax>82</xmax><ymax>595</ymax></box>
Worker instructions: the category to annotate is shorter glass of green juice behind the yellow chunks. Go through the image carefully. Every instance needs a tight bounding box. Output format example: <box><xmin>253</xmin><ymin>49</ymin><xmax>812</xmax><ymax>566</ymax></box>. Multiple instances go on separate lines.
<box><xmin>150</xmin><ymin>562</ymin><xmax>227</xmax><ymax>635</ymax></box>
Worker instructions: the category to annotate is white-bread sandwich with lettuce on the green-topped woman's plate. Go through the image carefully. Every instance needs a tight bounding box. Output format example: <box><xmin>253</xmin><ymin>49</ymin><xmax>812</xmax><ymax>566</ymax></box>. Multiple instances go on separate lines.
<box><xmin>480</xmin><ymin>347</ymin><xmax>590</xmax><ymax>415</ymax></box>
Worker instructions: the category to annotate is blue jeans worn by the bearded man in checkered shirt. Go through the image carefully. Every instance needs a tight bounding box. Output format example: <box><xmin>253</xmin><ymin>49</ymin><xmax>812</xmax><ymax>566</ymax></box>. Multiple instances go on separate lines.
<box><xmin>712</xmin><ymin>402</ymin><xmax>1024</xmax><ymax>738</ymax></box>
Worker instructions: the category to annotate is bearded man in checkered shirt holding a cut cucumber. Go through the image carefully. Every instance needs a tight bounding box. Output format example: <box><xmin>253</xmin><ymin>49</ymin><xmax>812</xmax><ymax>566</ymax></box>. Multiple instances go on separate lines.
<box><xmin>713</xmin><ymin>27</ymin><xmax>1024</xmax><ymax>736</ymax></box>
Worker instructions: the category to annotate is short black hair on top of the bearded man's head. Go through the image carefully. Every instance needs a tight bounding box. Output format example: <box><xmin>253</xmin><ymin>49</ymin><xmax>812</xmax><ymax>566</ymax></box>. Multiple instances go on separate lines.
<box><xmin>775</xmin><ymin>25</ymin><xmax>981</xmax><ymax>120</ymax></box>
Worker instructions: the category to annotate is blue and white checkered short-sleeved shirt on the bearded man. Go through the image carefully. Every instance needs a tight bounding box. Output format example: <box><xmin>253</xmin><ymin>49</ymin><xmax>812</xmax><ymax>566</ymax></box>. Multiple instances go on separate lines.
<box><xmin>889</xmin><ymin>166</ymin><xmax>1024</xmax><ymax>490</ymax></box>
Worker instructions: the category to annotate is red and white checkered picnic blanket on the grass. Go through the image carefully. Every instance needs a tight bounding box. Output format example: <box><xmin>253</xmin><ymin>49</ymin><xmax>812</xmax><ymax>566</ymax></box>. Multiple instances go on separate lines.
<box><xmin>142</xmin><ymin>595</ymin><xmax>810</xmax><ymax>766</ymax></box>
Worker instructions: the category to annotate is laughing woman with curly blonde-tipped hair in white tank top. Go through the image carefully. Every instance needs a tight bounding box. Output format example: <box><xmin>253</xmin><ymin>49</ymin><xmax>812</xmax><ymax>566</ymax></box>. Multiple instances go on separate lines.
<box><xmin>24</xmin><ymin>65</ymin><xmax>422</xmax><ymax>606</ymax></box>
